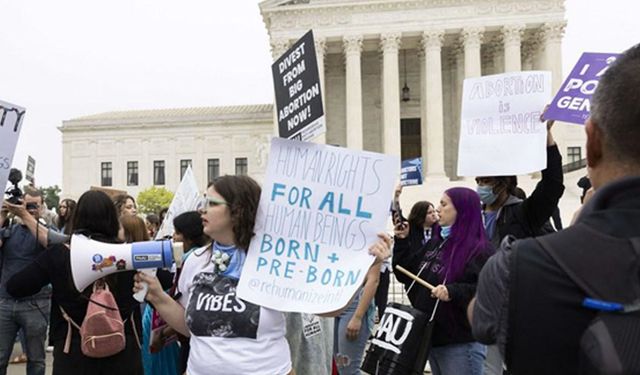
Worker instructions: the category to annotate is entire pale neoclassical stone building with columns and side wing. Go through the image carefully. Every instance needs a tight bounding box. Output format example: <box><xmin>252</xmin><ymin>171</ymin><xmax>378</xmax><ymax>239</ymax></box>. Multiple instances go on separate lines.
<box><xmin>60</xmin><ymin>0</ymin><xmax>584</xmax><ymax>222</ymax></box>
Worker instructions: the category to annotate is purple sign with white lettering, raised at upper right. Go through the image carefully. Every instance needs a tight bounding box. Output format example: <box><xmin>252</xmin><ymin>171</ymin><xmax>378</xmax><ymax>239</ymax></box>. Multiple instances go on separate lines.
<box><xmin>544</xmin><ymin>52</ymin><xmax>619</xmax><ymax>124</ymax></box>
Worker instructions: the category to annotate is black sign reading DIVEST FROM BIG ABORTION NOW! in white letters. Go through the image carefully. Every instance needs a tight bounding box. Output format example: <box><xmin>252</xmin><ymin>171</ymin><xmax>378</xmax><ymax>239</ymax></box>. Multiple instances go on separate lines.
<box><xmin>271</xmin><ymin>30</ymin><xmax>326</xmax><ymax>141</ymax></box>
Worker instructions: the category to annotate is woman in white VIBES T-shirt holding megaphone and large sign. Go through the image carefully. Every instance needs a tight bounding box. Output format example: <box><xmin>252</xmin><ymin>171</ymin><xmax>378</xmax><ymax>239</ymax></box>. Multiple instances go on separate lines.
<box><xmin>134</xmin><ymin>176</ymin><xmax>390</xmax><ymax>375</ymax></box>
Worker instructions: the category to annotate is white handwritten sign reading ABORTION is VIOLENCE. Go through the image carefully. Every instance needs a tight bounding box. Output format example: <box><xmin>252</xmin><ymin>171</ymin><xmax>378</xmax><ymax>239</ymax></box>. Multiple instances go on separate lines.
<box><xmin>458</xmin><ymin>71</ymin><xmax>551</xmax><ymax>176</ymax></box>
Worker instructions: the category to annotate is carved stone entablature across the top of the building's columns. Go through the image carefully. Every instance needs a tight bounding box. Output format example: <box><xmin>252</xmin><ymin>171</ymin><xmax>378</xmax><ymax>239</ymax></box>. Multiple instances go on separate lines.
<box><xmin>260</xmin><ymin>0</ymin><xmax>565</xmax><ymax>41</ymax></box>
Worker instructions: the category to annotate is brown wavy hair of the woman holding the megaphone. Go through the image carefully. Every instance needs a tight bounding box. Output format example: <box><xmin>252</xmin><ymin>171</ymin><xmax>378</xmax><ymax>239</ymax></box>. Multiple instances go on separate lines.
<box><xmin>207</xmin><ymin>175</ymin><xmax>261</xmax><ymax>250</ymax></box>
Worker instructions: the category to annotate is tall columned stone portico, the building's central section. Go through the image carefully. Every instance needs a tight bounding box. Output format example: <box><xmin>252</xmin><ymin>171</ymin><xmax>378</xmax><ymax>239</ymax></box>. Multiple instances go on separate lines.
<box><xmin>260</xmin><ymin>0</ymin><xmax>583</xmax><ymax>179</ymax></box>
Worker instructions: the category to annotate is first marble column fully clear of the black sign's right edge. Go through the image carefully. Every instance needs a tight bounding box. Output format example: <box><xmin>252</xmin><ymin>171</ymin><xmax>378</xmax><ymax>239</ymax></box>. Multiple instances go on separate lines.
<box><xmin>342</xmin><ymin>35</ymin><xmax>363</xmax><ymax>150</ymax></box>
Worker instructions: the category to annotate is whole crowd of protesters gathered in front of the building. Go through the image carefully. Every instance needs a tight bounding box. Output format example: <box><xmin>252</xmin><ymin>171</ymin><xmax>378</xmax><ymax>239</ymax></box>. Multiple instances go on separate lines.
<box><xmin>0</xmin><ymin>42</ymin><xmax>640</xmax><ymax>375</ymax></box>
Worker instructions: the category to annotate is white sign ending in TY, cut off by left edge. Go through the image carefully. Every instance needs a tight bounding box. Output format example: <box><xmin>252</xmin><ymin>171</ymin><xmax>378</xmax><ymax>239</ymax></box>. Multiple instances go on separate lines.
<box><xmin>0</xmin><ymin>100</ymin><xmax>25</xmax><ymax>200</ymax></box>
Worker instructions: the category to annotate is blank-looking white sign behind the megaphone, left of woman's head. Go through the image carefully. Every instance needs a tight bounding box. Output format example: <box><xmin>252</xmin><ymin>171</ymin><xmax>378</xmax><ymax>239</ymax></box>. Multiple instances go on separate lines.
<box><xmin>156</xmin><ymin>165</ymin><xmax>202</xmax><ymax>241</ymax></box>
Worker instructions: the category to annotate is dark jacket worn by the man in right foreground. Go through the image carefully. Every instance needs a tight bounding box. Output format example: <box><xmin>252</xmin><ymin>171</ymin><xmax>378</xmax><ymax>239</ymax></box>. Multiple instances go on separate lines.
<box><xmin>473</xmin><ymin>177</ymin><xmax>640</xmax><ymax>375</ymax></box>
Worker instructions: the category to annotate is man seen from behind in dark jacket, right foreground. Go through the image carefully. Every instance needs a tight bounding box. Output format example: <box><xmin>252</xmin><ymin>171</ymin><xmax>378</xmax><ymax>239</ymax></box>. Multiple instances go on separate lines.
<box><xmin>469</xmin><ymin>45</ymin><xmax>640</xmax><ymax>375</ymax></box>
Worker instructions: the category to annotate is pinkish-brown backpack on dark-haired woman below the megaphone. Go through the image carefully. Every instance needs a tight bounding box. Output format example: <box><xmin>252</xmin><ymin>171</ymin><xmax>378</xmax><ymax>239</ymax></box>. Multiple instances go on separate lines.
<box><xmin>60</xmin><ymin>281</ymin><xmax>140</xmax><ymax>358</ymax></box>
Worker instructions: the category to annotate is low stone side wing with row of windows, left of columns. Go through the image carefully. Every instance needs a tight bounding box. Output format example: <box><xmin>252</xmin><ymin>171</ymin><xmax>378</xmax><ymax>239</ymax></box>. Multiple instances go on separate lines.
<box><xmin>60</xmin><ymin>104</ymin><xmax>273</xmax><ymax>198</ymax></box>
